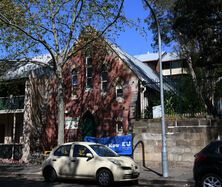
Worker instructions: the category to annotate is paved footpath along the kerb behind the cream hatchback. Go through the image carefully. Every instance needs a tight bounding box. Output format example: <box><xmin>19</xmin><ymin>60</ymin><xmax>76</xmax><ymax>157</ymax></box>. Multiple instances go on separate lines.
<box><xmin>0</xmin><ymin>163</ymin><xmax>194</xmax><ymax>187</ymax></box>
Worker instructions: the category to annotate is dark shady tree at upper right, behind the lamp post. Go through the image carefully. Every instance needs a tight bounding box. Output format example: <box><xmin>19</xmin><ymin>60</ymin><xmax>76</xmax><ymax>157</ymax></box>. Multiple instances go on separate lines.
<box><xmin>144</xmin><ymin>0</ymin><xmax>222</xmax><ymax>115</ymax></box>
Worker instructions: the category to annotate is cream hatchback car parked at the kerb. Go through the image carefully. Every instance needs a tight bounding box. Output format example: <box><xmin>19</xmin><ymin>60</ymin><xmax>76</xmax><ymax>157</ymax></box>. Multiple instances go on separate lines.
<box><xmin>42</xmin><ymin>142</ymin><xmax>139</xmax><ymax>186</ymax></box>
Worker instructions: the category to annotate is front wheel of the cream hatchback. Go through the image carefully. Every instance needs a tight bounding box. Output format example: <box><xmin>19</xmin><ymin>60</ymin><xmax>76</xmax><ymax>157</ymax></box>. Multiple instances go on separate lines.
<box><xmin>96</xmin><ymin>169</ymin><xmax>113</xmax><ymax>187</ymax></box>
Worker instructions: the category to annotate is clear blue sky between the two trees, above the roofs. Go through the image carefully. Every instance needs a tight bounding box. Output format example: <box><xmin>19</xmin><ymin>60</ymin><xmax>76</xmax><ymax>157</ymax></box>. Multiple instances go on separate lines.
<box><xmin>116</xmin><ymin>0</ymin><xmax>172</xmax><ymax>55</ymax></box>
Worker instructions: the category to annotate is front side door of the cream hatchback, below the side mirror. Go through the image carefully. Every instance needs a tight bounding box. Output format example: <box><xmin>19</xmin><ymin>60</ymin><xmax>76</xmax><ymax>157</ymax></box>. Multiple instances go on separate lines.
<box><xmin>70</xmin><ymin>144</ymin><xmax>96</xmax><ymax>178</ymax></box>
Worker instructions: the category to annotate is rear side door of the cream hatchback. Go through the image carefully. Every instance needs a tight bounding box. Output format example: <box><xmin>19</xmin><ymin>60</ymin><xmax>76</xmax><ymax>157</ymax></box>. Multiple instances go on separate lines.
<box><xmin>51</xmin><ymin>144</ymin><xmax>72</xmax><ymax>176</ymax></box>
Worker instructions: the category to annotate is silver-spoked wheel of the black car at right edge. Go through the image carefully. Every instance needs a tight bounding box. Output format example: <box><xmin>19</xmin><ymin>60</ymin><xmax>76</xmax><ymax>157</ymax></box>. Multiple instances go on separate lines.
<box><xmin>201</xmin><ymin>174</ymin><xmax>222</xmax><ymax>187</ymax></box>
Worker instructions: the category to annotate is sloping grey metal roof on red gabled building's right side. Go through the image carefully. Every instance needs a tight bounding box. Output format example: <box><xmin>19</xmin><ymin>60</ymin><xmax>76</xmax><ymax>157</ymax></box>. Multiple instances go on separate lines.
<box><xmin>108</xmin><ymin>42</ymin><xmax>175</xmax><ymax>91</ymax></box>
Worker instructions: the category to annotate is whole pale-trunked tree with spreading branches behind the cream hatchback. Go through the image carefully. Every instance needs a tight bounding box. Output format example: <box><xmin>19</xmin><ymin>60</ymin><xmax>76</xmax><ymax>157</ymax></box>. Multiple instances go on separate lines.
<box><xmin>0</xmin><ymin>0</ymin><xmax>125</xmax><ymax>159</ymax></box>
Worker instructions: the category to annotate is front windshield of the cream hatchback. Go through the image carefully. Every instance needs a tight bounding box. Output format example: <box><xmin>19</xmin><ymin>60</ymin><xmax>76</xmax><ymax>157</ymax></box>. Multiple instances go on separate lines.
<box><xmin>90</xmin><ymin>145</ymin><xmax>119</xmax><ymax>157</ymax></box>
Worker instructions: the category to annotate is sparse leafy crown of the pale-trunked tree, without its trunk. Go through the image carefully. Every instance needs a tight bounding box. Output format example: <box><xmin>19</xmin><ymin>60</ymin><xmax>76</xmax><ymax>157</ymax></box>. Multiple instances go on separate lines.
<box><xmin>0</xmin><ymin>0</ymin><xmax>126</xmax><ymax>59</ymax></box>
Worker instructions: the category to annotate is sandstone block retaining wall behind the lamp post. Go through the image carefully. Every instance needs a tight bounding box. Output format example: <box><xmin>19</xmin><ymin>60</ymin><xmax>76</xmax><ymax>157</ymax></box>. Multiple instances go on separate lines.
<box><xmin>133</xmin><ymin>119</ymin><xmax>222</xmax><ymax>166</ymax></box>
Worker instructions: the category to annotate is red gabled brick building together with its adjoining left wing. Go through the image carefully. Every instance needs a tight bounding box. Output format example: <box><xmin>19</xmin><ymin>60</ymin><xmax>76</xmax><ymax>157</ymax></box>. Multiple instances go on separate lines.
<box><xmin>0</xmin><ymin>39</ymin><xmax>172</xmax><ymax>156</ymax></box>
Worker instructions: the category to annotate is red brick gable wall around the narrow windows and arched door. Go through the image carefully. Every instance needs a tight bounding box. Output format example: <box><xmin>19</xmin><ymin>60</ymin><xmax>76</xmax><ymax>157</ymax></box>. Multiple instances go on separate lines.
<box><xmin>64</xmin><ymin>49</ymin><xmax>138</xmax><ymax>140</ymax></box>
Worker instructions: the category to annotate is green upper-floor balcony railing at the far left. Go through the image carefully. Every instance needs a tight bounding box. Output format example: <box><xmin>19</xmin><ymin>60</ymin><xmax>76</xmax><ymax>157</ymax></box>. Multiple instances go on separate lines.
<box><xmin>0</xmin><ymin>96</ymin><xmax>25</xmax><ymax>110</ymax></box>
